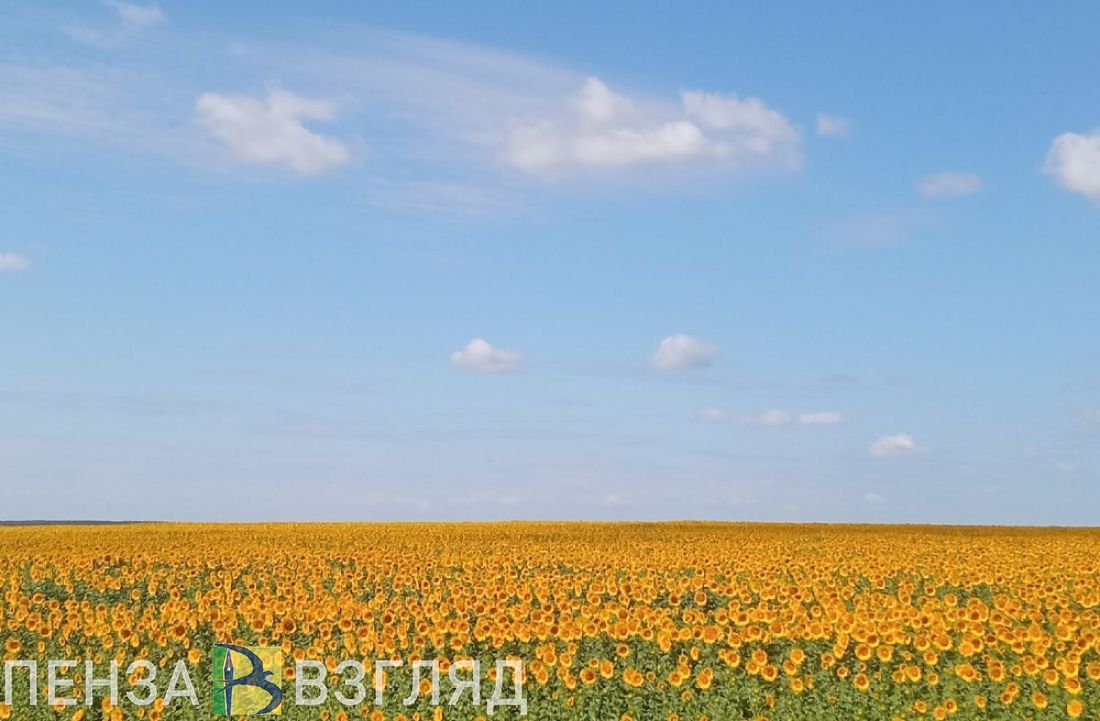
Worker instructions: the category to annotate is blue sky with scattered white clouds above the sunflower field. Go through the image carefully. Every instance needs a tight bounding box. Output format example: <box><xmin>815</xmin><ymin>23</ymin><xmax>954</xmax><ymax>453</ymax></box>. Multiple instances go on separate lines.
<box><xmin>0</xmin><ymin>0</ymin><xmax>1100</xmax><ymax>525</ymax></box>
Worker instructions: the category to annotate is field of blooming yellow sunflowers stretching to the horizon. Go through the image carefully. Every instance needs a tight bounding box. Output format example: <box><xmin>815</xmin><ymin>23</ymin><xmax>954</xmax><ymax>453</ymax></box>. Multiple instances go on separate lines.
<box><xmin>0</xmin><ymin>523</ymin><xmax>1100</xmax><ymax>721</ymax></box>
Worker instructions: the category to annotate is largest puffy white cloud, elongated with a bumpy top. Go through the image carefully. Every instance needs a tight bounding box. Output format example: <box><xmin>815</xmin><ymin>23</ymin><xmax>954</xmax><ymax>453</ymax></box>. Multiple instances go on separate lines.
<box><xmin>505</xmin><ymin>77</ymin><xmax>802</xmax><ymax>176</ymax></box>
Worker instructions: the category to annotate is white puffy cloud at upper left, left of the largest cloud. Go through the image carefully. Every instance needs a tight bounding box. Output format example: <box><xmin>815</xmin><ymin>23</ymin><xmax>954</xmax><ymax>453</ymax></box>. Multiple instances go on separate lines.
<box><xmin>195</xmin><ymin>90</ymin><xmax>351</xmax><ymax>175</ymax></box>
